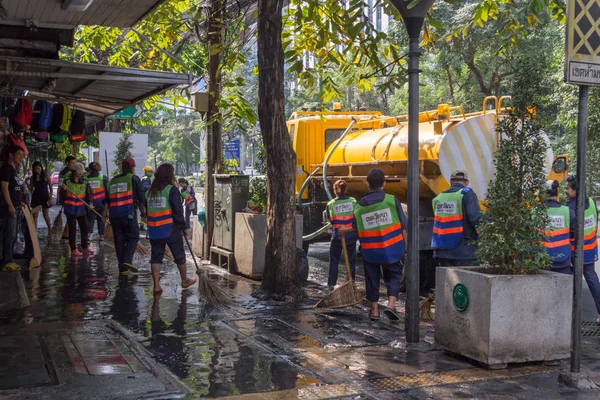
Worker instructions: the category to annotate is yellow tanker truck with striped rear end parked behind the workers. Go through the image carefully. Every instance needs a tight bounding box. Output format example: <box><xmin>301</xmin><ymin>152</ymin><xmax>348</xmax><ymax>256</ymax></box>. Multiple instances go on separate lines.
<box><xmin>287</xmin><ymin>96</ymin><xmax>568</xmax><ymax>290</ymax></box>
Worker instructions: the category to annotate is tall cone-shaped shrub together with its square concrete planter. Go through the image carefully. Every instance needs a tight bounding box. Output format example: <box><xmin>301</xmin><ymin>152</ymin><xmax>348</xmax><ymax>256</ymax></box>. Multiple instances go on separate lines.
<box><xmin>435</xmin><ymin>57</ymin><xmax>573</xmax><ymax>367</ymax></box>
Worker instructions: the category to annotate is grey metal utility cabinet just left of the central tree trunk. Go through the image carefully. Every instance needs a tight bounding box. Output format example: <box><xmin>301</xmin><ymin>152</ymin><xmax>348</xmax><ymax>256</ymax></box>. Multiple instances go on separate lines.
<box><xmin>211</xmin><ymin>175</ymin><xmax>250</xmax><ymax>269</ymax></box>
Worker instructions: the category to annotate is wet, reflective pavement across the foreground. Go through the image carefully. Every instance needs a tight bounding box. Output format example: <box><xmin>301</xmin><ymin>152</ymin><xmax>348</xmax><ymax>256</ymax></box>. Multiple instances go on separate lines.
<box><xmin>0</xmin><ymin>205</ymin><xmax>600</xmax><ymax>399</ymax></box>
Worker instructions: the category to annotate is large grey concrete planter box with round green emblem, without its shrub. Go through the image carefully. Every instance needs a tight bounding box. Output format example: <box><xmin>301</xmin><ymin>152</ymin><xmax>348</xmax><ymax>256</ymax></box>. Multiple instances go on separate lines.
<box><xmin>435</xmin><ymin>267</ymin><xmax>573</xmax><ymax>367</ymax></box>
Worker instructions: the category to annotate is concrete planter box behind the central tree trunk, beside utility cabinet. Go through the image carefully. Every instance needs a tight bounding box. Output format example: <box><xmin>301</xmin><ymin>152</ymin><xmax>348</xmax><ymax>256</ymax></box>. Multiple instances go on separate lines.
<box><xmin>234</xmin><ymin>213</ymin><xmax>302</xmax><ymax>279</ymax></box>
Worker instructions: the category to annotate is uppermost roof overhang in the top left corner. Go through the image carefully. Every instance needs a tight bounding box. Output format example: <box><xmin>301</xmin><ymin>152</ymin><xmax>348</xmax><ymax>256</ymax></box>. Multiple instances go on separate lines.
<box><xmin>0</xmin><ymin>0</ymin><xmax>164</xmax><ymax>28</ymax></box>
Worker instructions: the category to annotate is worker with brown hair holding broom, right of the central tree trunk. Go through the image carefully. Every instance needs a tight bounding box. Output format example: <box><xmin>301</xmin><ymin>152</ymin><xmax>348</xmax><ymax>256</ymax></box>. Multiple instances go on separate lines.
<box><xmin>326</xmin><ymin>180</ymin><xmax>358</xmax><ymax>290</ymax></box>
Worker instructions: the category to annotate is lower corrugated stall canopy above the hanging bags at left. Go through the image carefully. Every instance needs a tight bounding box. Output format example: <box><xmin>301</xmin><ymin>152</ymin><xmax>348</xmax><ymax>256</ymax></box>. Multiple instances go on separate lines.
<box><xmin>0</xmin><ymin>56</ymin><xmax>193</xmax><ymax>117</ymax></box>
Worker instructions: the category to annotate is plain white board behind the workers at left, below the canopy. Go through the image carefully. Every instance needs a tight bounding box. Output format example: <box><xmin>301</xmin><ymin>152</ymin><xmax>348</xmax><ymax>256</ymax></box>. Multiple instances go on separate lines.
<box><xmin>100</xmin><ymin>132</ymin><xmax>148</xmax><ymax>177</ymax></box>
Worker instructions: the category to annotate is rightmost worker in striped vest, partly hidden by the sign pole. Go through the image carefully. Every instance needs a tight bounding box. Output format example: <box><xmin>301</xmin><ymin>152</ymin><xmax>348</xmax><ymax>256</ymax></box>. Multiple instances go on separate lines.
<box><xmin>565</xmin><ymin>175</ymin><xmax>600</xmax><ymax>324</ymax></box>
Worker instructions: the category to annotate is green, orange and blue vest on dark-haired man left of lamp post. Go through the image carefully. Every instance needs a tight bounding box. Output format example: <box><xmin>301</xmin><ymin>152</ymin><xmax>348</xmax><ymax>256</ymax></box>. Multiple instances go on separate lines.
<box><xmin>354</xmin><ymin>194</ymin><xmax>405</xmax><ymax>264</ymax></box>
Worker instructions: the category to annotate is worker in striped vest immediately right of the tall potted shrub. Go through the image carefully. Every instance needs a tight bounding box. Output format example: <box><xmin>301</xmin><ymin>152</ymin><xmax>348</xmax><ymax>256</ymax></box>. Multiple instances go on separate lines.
<box><xmin>544</xmin><ymin>180</ymin><xmax>571</xmax><ymax>274</ymax></box>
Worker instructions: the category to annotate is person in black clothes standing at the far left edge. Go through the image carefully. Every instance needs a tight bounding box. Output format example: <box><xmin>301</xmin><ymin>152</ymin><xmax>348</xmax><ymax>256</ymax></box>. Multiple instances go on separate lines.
<box><xmin>0</xmin><ymin>146</ymin><xmax>23</xmax><ymax>271</ymax></box>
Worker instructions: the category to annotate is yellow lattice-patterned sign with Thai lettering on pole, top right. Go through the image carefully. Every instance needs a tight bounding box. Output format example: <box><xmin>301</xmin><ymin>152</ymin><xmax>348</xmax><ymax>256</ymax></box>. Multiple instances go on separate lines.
<box><xmin>565</xmin><ymin>0</ymin><xmax>600</xmax><ymax>86</ymax></box>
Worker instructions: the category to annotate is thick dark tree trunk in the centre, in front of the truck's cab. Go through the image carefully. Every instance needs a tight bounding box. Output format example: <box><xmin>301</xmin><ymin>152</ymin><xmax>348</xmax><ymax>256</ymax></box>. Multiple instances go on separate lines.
<box><xmin>258</xmin><ymin>0</ymin><xmax>301</xmax><ymax>298</ymax></box>
